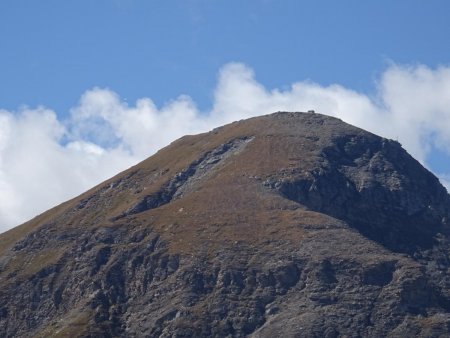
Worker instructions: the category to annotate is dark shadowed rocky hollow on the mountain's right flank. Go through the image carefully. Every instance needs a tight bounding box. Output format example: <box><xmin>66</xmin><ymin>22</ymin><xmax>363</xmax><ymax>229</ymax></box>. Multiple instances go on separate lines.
<box><xmin>272</xmin><ymin>135</ymin><xmax>449</xmax><ymax>254</ymax></box>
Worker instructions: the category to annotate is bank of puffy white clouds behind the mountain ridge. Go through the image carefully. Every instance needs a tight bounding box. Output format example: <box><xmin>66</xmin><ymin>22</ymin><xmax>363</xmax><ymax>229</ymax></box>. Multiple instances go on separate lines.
<box><xmin>0</xmin><ymin>63</ymin><xmax>450</xmax><ymax>231</ymax></box>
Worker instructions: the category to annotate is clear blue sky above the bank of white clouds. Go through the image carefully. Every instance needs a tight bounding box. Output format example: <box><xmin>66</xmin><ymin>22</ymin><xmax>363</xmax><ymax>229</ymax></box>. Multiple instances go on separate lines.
<box><xmin>0</xmin><ymin>0</ymin><xmax>450</xmax><ymax>114</ymax></box>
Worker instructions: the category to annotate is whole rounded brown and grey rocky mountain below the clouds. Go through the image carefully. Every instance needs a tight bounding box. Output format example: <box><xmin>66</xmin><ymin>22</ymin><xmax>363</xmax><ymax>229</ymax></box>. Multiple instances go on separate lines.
<box><xmin>0</xmin><ymin>113</ymin><xmax>450</xmax><ymax>337</ymax></box>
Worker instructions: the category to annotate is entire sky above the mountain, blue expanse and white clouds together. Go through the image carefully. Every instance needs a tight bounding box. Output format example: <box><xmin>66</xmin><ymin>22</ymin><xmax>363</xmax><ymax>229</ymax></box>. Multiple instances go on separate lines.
<box><xmin>0</xmin><ymin>0</ymin><xmax>450</xmax><ymax>231</ymax></box>
